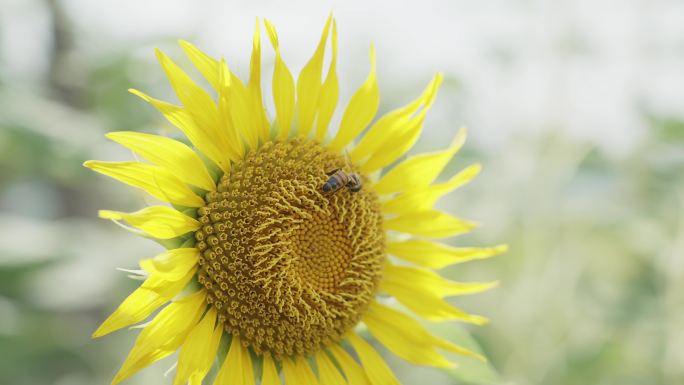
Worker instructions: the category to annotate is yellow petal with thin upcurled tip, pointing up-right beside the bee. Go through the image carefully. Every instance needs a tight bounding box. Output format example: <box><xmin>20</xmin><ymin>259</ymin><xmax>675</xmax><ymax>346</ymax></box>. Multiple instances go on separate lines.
<box><xmin>373</xmin><ymin>129</ymin><xmax>466</xmax><ymax>195</ymax></box>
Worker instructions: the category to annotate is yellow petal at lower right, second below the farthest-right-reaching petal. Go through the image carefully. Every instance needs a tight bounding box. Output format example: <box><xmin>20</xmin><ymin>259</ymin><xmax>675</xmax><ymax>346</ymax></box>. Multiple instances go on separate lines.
<box><xmin>380</xmin><ymin>272</ymin><xmax>487</xmax><ymax>325</ymax></box>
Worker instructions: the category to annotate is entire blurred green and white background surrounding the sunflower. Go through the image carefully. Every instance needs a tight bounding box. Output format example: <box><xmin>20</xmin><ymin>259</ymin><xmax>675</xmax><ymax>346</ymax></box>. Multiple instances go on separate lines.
<box><xmin>0</xmin><ymin>0</ymin><xmax>684</xmax><ymax>385</ymax></box>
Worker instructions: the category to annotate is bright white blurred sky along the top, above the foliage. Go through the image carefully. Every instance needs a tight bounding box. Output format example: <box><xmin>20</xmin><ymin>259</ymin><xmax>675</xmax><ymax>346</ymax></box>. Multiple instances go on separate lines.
<box><xmin>0</xmin><ymin>0</ymin><xmax>684</xmax><ymax>158</ymax></box>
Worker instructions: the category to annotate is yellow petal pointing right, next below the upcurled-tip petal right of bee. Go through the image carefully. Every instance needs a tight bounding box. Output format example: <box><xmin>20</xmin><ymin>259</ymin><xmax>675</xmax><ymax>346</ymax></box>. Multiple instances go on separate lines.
<box><xmin>382</xmin><ymin>164</ymin><xmax>480</xmax><ymax>214</ymax></box>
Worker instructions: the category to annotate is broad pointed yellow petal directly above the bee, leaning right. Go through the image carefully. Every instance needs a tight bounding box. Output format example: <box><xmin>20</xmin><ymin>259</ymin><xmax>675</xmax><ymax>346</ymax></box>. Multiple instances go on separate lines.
<box><xmin>330</xmin><ymin>46</ymin><xmax>380</xmax><ymax>152</ymax></box>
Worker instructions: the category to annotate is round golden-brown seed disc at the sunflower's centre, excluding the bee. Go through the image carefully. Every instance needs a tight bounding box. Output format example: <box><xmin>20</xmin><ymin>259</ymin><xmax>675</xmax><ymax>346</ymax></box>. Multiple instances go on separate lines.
<box><xmin>195</xmin><ymin>139</ymin><xmax>385</xmax><ymax>357</ymax></box>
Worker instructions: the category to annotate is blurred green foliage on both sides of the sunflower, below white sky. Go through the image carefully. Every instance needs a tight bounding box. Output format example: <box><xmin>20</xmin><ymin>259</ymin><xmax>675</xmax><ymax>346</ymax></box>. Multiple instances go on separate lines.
<box><xmin>0</xmin><ymin>2</ymin><xmax>684</xmax><ymax>385</ymax></box>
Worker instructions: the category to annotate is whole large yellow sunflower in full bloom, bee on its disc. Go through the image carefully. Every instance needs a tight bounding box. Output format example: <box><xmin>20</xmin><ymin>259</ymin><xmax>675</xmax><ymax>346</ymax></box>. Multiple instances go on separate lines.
<box><xmin>85</xmin><ymin>17</ymin><xmax>504</xmax><ymax>385</ymax></box>
